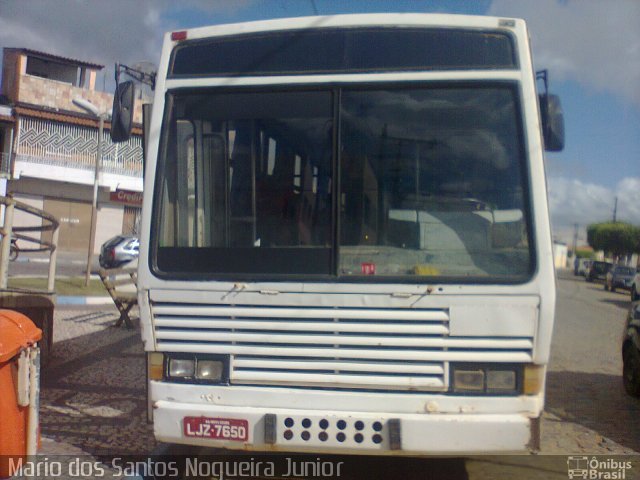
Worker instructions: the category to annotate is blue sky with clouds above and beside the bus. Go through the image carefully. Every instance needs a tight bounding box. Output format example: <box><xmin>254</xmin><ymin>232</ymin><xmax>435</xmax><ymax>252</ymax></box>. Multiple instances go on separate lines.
<box><xmin>0</xmin><ymin>0</ymin><xmax>640</xmax><ymax>245</ymax></box>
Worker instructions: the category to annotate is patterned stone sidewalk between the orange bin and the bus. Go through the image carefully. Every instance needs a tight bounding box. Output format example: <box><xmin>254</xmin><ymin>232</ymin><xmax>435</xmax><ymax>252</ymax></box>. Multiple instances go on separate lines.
<box><xmin>38</xmin><ymin>307</ymin><xmax>155</xmax><ymax>456</ymax></box>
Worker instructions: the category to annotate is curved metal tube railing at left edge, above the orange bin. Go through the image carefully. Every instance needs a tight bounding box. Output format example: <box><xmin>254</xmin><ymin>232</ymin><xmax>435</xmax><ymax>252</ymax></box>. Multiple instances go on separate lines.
<box><xmin>0</xmin><ymin>196</ymin><xmax>60</xmax><ymax>292</ymax></box>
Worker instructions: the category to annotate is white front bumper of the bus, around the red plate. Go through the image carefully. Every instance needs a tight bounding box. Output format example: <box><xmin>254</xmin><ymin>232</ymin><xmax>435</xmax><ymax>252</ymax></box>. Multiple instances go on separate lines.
<box><xmin>153</xmin><ymin>386</ymin><xmax>539</xmax><ymax>455</ymax></box>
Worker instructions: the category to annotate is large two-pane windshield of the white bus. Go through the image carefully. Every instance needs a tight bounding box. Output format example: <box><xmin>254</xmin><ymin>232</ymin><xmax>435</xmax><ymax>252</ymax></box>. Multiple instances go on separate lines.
<box><xmin>152</xmin><ymin>82</ymin><xmax>534</xmax><ymax>282</ymax></box>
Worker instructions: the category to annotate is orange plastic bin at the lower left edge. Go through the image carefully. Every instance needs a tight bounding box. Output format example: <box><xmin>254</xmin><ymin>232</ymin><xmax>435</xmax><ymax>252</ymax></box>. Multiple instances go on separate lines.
<box><xmin>0</xmin><ymin>310</ymin><xmax>42</xmax><ymax>478</ymax></box>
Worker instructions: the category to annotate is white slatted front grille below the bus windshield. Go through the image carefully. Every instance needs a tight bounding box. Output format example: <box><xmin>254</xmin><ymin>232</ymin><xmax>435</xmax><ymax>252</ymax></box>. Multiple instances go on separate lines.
<box><xmin>153</xmin><ymin>303</ymin><xmax>533</xmax><ymax>391</ymax></box>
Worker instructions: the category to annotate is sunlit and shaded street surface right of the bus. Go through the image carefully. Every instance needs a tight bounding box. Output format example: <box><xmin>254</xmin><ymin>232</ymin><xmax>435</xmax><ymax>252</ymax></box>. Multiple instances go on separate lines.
<box><xmin>543</xmin><ymin>274</ymin><xmax>640</xmax><ymax>456</ymax></box>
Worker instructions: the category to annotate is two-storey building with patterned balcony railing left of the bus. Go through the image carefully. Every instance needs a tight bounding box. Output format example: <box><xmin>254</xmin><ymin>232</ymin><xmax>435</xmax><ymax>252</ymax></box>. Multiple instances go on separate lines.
<box><xmin>0</xmin><ymin>48</ymin><xmax>142</xmax><ymax>251</ymax></box>
